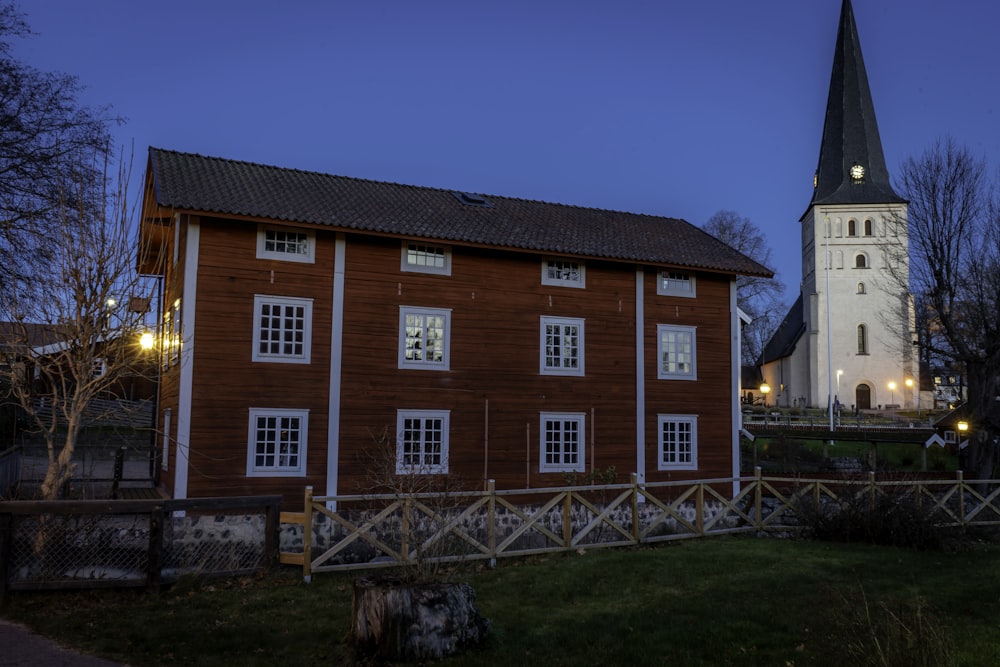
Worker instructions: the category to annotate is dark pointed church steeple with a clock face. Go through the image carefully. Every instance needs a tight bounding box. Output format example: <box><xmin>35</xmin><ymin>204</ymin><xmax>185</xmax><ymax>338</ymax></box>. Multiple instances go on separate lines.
<box><xmin>812</xmin><ymin>0</ymin><xmax>904</xmax><ymax>206</ymax></box>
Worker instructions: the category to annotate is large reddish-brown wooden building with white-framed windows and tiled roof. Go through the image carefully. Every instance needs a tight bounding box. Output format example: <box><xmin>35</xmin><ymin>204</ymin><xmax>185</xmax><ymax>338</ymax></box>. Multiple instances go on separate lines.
<box><xmin>140</xmin><ymin>148</ymin><xmax>771</xmax><ymax>505</ymax></box>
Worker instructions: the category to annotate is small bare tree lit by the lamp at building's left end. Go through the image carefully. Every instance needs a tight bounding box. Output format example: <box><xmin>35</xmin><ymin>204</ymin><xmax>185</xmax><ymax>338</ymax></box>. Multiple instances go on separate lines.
<box><xmin>0</xmin><ymin>150</ymin><xmax>155</xmax><ymax>499</ymax></box>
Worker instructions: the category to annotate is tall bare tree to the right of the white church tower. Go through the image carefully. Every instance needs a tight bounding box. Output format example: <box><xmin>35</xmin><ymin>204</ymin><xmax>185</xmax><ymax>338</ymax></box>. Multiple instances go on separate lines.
<box><xmin>887</xmin><ymin>138</ymin><xmax>1000</xmax><ymax>479</ymax></box>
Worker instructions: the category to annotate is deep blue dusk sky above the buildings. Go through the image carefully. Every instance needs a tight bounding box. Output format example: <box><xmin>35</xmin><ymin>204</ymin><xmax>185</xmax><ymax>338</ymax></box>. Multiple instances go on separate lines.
<box><xmin>15</xmin><ymin>0</ymin><xmax>1000</xmax><ymax>299</ymax></box>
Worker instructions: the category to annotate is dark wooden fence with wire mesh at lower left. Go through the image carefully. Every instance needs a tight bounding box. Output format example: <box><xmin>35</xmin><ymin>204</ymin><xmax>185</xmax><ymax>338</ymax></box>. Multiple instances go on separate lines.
<box><xmin>0</xmin><ymin>496</ymin><xmax>281</xmax><ymax>600</ymax></box>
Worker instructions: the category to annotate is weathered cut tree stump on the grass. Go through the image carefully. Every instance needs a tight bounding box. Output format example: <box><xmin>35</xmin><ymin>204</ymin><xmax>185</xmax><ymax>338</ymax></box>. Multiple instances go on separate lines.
<box><xmin>350</xmin><ymin>577</ymin><xmax>490</xmax><ymax>660</ymax></box>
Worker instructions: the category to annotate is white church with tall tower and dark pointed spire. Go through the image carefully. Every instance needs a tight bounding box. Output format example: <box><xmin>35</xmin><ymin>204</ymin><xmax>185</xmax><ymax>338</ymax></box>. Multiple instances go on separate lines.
<box><xmin>760</xmin><ymin>0</ymin><xmax>920</xmax><ymax>411</ymax></box>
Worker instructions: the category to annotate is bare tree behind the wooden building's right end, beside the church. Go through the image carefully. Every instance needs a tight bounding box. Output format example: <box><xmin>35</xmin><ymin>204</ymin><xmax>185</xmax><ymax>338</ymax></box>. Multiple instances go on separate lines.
<box><xmin>702</xmin><ymin>211</ymin><xmax>788</xmax><ymax>363</ymax></box>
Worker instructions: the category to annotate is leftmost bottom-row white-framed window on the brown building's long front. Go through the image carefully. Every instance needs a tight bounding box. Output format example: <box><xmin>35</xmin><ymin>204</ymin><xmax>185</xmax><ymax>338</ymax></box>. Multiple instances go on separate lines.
<box><xmin>247</xmin><ymin>408</ymin><xmax>309</xmax><ymax>477</ymax></box>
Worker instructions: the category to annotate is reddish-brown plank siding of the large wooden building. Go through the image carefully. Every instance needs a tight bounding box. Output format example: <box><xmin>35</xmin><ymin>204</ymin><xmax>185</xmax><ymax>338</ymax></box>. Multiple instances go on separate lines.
<box><xmin>148</xmin><ymin>211</ymin><xmax>735</xmax><ymax>509</ymax></box>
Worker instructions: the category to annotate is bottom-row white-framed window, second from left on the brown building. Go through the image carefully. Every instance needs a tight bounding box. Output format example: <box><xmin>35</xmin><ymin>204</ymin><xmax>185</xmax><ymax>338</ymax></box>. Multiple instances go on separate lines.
<box><xmin>396</xmin><ymin>410</ymin><xmax>451</xmax><ymax>475</ymax></box>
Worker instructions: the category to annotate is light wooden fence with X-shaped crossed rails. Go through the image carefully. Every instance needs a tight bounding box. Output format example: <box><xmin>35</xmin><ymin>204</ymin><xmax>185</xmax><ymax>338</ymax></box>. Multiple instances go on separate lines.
<box><xmin>281</xmin><ymin>468</ymin><xmax>1000</xmax><ymax>581</ymax></box>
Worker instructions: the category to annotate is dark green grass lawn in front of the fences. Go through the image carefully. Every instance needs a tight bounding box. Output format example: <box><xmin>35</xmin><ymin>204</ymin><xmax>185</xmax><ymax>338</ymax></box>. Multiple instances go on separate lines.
<box><xmin>0</xmin><ymin>537</ymin><xmax>1000</xmax><ymax>667</ymax></box>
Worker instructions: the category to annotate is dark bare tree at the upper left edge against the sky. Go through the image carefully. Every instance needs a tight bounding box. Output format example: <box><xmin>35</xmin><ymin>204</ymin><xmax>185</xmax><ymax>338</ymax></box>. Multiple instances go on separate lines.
<box><xmin>0</xmin><ymin>1</ymin><xmax>120</xmax><ymax>292</ymax></box>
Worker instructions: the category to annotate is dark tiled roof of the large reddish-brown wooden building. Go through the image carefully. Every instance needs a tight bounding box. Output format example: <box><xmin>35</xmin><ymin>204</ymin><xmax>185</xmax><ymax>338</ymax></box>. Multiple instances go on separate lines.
<box><xmin>149</xmin><ymin>148</ymin><xmax>772</xmax><ymax>277</ymax></box>
